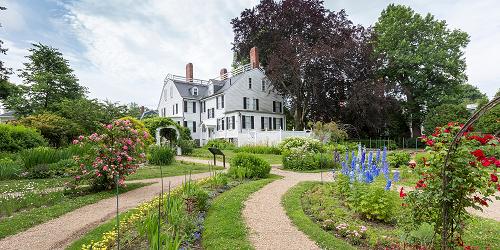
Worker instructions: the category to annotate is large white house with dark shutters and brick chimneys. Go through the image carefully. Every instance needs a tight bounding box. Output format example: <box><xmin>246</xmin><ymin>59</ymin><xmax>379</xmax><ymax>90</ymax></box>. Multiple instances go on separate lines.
<box><xmin>158</xmin><ymin>47</ymin><xmax>291</xmax><ymax>145</ymax></box>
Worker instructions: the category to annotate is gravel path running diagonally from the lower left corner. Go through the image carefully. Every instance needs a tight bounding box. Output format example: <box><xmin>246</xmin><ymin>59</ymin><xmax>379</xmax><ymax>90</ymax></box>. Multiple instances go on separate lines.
<box><xmin>0</xmin><ymin>173</ymin><xmax>210</xmax><ymax>250</ymax></box>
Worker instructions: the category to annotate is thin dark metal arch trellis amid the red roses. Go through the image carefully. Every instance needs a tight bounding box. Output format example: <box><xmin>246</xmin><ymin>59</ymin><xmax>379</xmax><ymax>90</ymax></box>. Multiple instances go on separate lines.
<box><xmin>441</xmin><ymin>96</ymin><xmax>500</xmax><ymax>249</ymax></box>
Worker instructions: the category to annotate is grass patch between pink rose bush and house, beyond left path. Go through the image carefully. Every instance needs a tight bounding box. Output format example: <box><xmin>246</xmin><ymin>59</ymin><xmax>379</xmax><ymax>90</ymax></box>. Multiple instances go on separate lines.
<box><xmin>127</xmin><ymin>161</ymin><xmax>222</xmax><ymax>180</ymax></box>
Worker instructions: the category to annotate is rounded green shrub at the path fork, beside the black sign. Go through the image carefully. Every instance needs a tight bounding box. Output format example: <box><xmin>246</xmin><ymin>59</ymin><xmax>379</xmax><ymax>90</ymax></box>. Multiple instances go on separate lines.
<box><xmin>228</xmin><ymin>153</ymin><xmax>271</xmax><ymax>179</ymax></box>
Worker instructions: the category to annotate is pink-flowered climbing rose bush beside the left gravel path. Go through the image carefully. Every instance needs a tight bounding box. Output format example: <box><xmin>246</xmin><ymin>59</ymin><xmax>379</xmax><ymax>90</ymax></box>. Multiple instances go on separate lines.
<box><xmin>73</xmin><ymin>120</ymin><xmax>149</xmax><ymax>190</ymax></box>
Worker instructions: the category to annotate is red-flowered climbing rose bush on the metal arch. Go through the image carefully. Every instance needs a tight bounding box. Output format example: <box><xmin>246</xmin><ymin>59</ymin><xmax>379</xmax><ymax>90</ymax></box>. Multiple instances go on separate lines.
<box><xmin>400</xmin><ymin>123</ymin><xmax>500</xmax><ymax>246</ymax></box>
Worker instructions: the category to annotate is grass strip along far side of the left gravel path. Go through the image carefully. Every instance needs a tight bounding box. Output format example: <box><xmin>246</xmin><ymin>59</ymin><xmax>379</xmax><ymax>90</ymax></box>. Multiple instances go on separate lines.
<box><xmin>0</xmin><ymin>183</ymin><xmax>147</xmax><ymax>239</ymax></box>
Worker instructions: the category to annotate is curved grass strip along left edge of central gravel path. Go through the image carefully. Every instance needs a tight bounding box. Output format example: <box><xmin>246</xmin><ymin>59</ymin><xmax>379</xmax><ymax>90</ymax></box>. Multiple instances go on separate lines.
<box><xmin>202</xmin><ymin>176</ymin><xmax>279</xmax><ymax>249</ymax></box>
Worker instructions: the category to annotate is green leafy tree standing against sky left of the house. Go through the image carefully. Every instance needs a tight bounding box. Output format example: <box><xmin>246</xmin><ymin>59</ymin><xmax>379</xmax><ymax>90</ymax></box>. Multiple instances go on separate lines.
<box><xmin>5</xmin><ymin>43</ymin><xmax>86</xmax><ymax>116</ymax></box>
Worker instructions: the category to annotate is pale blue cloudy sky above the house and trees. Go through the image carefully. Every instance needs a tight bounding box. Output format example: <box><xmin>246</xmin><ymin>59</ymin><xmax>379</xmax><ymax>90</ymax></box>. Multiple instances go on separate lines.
<box><xmin>0</xmin><ymin>0</ymin><xmax>500</xmax><ymax>108</ymax></box>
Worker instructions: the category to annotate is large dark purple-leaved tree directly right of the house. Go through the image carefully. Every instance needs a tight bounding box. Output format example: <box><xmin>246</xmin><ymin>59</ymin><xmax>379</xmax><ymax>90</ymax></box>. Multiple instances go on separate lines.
<box><xmin>231</xmin><ymin>0</ymin><xmax>376</xmax><ymax>129</ymax></box>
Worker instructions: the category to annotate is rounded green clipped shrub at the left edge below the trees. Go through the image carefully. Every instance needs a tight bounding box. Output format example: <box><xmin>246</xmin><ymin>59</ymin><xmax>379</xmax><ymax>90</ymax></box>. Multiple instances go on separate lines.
<box><xmin>0</xmin><ymin>124</ymin><xmax>47</xmax><ymax>152</ymax></box>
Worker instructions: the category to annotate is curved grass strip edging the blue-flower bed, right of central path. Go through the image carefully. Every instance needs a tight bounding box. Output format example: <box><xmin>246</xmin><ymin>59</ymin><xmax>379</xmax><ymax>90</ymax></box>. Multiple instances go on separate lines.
<box><xmin>282</xmin><ymin>182</ymin><xmax>356</xmax><ymax>249</ymax></box>
